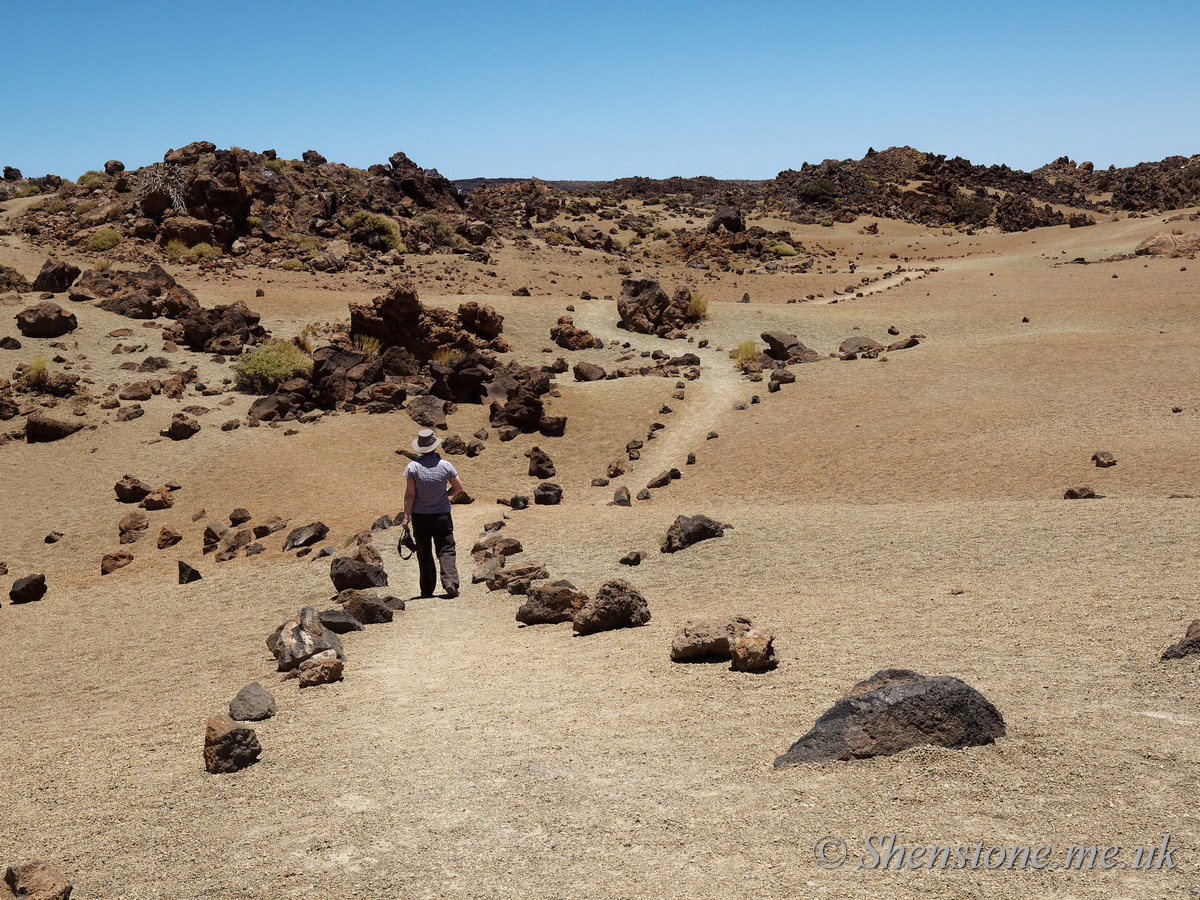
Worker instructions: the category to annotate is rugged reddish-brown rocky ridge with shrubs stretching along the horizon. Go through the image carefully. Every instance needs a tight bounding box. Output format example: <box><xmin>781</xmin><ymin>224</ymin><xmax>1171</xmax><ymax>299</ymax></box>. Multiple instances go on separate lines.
<box><xmin>0</xmin><ymin>142</ymin><xmax>1200</xmax><ymax>277</ymax></box>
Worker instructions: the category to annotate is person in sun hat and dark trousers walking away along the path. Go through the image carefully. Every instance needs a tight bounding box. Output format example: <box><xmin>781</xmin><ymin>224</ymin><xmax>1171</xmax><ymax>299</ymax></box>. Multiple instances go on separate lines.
<box><xmin>402</xmin><ymin>428</ymin><xmax>462</xmax><ymax>598</ymax></box>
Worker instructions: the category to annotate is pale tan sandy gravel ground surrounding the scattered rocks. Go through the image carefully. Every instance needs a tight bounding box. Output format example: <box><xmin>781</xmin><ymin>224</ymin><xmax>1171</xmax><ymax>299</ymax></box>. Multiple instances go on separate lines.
<box><xmin>0</xmin><ymin>204</ymin><xmax>1200</xmax><ymax>898</ymax></box>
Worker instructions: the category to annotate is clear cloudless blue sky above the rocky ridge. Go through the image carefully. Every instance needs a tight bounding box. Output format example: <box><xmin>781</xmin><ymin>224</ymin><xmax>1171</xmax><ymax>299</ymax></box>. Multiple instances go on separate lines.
<box><xmin>0</xmin><ymin>0</ymin><xmax>1200</xmax><ymax>180</ymax></box>
